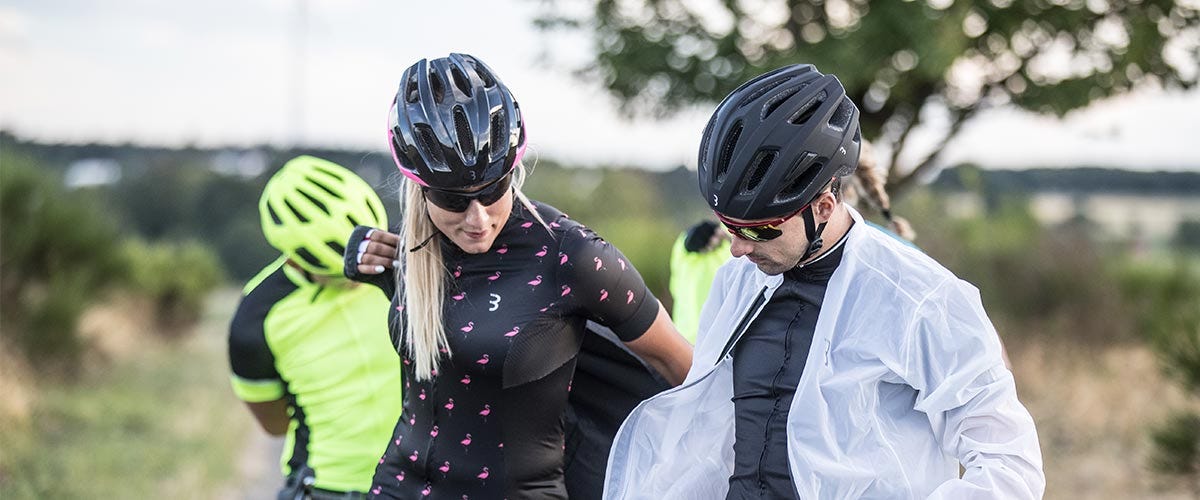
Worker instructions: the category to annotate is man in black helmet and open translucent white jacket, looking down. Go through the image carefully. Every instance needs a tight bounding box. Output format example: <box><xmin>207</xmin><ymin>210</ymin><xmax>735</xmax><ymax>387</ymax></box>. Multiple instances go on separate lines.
<box><xmin>605</xmin><ymin>65</ymin><xmax>1045</xmax><ymax>500</ymax></box>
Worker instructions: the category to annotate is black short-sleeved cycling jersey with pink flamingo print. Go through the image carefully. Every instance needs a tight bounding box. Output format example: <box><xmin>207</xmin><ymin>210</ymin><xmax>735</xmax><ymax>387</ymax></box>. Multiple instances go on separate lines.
<box><xmin>352</xmin><ymin>204</ymin><xmax>659</xmax><ymax>499</ymax></box>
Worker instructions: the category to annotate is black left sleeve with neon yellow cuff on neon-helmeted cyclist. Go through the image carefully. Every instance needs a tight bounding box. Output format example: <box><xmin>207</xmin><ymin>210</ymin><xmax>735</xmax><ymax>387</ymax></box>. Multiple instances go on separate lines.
<box><xmin>229</xmin><ymin>270</ymin><xmax>287</xmax><ymax>403</ymax></box>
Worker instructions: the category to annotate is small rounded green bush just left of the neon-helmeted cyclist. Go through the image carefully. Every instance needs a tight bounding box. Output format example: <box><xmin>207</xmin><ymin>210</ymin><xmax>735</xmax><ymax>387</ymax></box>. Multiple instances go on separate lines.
<box><xmin>122</xmin><ymin>239</ymin><xmax>224</xmax><ymax>333</ymax></box>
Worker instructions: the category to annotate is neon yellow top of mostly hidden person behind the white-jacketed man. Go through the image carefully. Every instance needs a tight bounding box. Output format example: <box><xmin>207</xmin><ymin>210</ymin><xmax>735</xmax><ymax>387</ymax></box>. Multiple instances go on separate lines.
<box><xmin>670</xmin><ymin>233</ymin><xmax>730</xmax><ymax>344</ymax></box>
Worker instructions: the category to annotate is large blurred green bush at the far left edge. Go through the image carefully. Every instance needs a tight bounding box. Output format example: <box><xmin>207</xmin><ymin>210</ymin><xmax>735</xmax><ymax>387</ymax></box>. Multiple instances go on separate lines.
<box><xmin>0</xmin><ymin>150</ymin><xmax>122</xmax><ymax>371</ymax></box>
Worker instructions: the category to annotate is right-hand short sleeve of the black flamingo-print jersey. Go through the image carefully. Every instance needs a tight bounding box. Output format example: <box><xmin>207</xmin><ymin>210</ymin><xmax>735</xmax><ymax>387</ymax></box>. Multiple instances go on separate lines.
<box><xmin>558</xmin><ymin>221</ymin><xmax>659</xmax><ymax>342</ymax></box>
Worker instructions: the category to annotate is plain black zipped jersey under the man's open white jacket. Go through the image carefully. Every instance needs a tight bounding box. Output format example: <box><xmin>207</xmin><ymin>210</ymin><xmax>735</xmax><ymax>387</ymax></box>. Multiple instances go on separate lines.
<box><xmin>726</xmin><ymin>231</ymin><xmax>845</xmax><ymax>500</ymax></box>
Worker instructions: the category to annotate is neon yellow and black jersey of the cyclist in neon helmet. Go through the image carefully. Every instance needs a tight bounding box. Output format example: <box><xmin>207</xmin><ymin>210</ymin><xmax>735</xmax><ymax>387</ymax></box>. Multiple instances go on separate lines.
<box><xmin>229</xmin><ymin>258</ymin><xmax>401</xmax><ymax>492</ymax></box>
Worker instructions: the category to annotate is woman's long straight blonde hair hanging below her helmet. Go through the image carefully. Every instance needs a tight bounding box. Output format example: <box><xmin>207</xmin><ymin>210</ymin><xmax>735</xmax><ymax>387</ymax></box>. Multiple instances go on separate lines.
<box><xmin>391</xmin><ymin>163</ymin><xmax>550</xmax><ymax>380</ymax></box>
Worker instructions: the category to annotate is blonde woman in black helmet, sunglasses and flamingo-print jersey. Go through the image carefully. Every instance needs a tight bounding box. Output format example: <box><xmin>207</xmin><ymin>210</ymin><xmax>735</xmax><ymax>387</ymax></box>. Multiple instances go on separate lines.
<box><xmin>347</xmin><ymin>54</ymin><xmax>691</xmax><ymax>499</ymax></box>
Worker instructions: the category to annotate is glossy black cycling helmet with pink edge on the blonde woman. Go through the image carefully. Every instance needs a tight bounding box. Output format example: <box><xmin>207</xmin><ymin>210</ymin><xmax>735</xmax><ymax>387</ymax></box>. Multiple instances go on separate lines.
<box><xmin>388</xmin><ymin>54</ymin><xmax>526</xmax><ymax>189</ymax></box>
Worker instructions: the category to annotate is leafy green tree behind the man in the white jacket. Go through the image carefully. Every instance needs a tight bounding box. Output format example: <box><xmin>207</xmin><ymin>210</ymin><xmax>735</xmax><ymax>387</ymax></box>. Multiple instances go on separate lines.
<box><xmin>535</xmin><ymin>0</ymin><xmax>1200</xmax><ymax>191</ymax></box>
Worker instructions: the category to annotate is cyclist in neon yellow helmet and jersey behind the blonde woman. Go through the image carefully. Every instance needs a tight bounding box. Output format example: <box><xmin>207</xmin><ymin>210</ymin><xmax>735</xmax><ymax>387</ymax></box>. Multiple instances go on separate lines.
<box><xmin>229</xmin><ymin>156</ymin><xmax>401</xmax><ymax>499</ymax></box>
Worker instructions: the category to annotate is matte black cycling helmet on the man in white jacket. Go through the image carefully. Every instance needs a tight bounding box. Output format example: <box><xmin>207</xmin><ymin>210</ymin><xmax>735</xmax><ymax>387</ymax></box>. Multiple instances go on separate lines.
<box><xmin>698</xmin><ymin>65</ymin><xmax>862</xmax><ymax>221</ymax></box>
